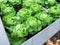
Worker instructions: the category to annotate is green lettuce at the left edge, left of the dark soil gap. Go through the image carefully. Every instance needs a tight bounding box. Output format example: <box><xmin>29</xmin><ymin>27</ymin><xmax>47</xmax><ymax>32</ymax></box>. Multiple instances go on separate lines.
<box><xmin>1</xmin><ymin>4</ymin><xmax>16</xmax><ymax>15</ymax></box>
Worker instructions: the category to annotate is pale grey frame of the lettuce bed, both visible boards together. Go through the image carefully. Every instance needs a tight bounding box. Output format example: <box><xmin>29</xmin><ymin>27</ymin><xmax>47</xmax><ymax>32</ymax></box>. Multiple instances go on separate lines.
<box><xmin>0</xmin><ymin>18</ymin><xmax>60</xmax><ymax>45</ymax></box>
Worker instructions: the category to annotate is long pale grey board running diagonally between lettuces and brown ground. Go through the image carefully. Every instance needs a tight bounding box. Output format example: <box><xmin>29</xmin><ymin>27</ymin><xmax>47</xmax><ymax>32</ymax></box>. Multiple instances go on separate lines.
<box><xmin>22</xmin><ymin>19</ymin><xmax>60</xmax><ymax>45</ymax></box>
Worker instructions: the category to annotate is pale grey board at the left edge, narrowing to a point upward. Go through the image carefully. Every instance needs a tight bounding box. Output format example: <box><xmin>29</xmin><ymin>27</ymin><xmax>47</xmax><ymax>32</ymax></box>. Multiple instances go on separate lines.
<box><xmin>0</xmin><ymin>17</ymin><xmax>10</xmax><ymax>45</ymax></box>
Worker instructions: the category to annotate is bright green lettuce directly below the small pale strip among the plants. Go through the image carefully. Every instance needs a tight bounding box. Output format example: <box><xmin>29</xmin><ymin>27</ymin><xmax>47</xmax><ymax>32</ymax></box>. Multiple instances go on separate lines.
<box><xmin>35</xmin><ymin>12</ymin><xmax>53</xmax><ymax>26</ymax></box>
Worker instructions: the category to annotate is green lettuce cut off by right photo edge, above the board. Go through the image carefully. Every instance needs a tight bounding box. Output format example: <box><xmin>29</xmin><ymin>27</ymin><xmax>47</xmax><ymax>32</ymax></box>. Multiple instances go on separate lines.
<box><xmin>49</xmin><ymin>4</ymin><xmax>60</xmax><ymax>20</ymax></box>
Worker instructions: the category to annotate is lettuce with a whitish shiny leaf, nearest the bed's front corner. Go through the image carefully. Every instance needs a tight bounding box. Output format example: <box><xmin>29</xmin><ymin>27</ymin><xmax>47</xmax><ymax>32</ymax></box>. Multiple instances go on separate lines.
<box><xmin>11</xmin><ymin>24</ymin><xmax>28</xmax><ymax>37</ymax></box>
